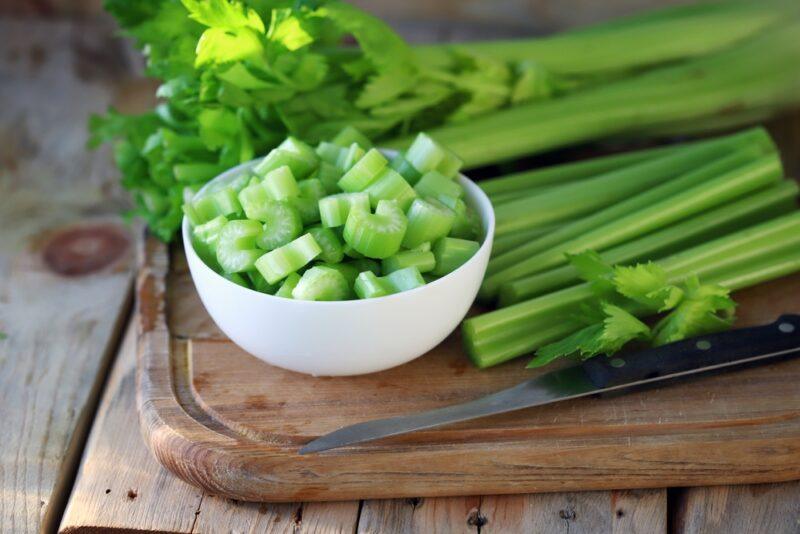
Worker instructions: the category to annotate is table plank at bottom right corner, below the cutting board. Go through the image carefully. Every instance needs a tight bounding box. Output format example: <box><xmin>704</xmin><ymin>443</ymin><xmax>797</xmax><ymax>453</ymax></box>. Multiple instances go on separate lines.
<box><xmin>672</xmin><ymin>482</ymin><xmax>800</xmax><ymax>534</ymax></box>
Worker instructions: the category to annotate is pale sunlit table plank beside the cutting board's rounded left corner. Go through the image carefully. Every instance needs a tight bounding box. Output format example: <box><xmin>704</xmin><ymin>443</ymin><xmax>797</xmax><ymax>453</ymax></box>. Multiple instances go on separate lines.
<box><xmin>60</xmin><ymin>320</ymin><xmax>202</xmax><ymax>533</ymax></box>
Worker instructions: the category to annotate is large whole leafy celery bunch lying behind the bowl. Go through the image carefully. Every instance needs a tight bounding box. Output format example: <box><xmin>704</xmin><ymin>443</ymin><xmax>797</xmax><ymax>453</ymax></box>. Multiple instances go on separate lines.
<box><xmin>90</xmin><ymin>0</ymin><xmax>798</xmax><ymax>240</ymax></box>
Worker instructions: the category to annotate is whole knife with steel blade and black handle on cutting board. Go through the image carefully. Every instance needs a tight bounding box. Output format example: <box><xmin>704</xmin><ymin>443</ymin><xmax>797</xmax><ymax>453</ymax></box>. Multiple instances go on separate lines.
<box><xmin>299</xmin><ymin>315</ymin><xmax>800</xmax><ymax>454</ymax></box>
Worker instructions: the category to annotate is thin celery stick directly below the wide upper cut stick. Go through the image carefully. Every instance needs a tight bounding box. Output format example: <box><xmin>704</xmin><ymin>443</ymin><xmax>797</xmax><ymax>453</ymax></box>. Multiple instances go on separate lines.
<box><xmin>487</xmin><ymin>142</ymin><xmax>774</xmax><ymax>275</ymax></box>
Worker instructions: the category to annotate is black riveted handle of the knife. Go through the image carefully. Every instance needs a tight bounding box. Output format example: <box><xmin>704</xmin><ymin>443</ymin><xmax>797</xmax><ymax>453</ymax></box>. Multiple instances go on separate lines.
<box><xmin>583</xmin><ymin>315</ymin><xmax>800</xmax><ymax>389</ymax></box>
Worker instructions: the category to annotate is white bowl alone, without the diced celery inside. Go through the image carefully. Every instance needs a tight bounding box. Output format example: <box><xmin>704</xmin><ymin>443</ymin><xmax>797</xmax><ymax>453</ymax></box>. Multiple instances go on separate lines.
<box><xmin>182</xmin><ymin>156</ymin><xmax>494</xmax><ymax>376</ymax></box>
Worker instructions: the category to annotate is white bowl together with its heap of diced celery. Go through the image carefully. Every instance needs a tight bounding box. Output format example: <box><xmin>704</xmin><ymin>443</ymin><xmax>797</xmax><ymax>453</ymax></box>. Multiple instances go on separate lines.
<box><xmin>183</xmin><ymin>128</ymin><xmax>494</xmax><ymax>375</ymax></box>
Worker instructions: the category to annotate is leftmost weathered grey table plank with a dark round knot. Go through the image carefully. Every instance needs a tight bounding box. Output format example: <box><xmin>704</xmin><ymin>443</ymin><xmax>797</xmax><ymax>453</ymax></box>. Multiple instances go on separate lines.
<box><xmin>0</xmin><ymin>19</ymin><xmax>133</xmax><ymax>532</ymax></box>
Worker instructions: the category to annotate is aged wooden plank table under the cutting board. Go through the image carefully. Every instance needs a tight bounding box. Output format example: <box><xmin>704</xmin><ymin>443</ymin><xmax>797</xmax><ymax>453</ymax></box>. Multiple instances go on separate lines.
<box><xmin>0</xmin><ymin>10</ymin><xmax>800</xmax><ymax>534</ymax></box>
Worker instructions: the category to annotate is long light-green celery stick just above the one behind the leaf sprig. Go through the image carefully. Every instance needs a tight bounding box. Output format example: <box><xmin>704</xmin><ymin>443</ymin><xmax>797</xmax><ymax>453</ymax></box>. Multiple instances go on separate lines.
<box><xmin>481</xmin><ymin>154</ymin><xmax>783</xmax><ymax>298</ymax></box>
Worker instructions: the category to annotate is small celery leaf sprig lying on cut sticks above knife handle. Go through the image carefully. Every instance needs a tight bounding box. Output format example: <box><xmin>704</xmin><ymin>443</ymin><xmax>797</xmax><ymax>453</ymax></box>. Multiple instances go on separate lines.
<box><xmin>528</xmin><ymin>251</ymin><xmax>736</xmax><ymax>368</ymax></box>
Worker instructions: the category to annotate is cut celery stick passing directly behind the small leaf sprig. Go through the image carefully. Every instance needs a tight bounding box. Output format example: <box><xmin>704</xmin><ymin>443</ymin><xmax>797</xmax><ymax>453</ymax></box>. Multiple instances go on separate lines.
<box><xmin>499</xmin><ymin>181</ymin><xmax>798</xmax><ymax>306</ymax></box>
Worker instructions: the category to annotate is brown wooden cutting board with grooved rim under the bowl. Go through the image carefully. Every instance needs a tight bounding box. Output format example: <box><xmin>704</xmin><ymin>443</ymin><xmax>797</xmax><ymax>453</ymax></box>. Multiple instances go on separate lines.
<box><xmin>137</xmin><ymin>239</ymin><xmax>800</xmax><ymax>501</ymax></box>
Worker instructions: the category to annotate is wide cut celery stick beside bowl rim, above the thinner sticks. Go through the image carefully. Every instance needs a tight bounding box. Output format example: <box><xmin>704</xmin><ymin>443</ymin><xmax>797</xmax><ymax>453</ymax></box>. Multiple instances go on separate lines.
<box><xmin>495</xmin><ymin>129</ymin><xmax>772</xmax><ymax>236</ymax></box>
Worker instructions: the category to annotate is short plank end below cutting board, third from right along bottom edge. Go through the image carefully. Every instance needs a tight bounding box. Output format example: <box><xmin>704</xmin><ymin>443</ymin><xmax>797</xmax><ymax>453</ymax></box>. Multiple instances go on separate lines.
<box><xmin>358</xmin><ymin>497</ymin><xmax>480</xmax><ymax>534</ymax></box>
